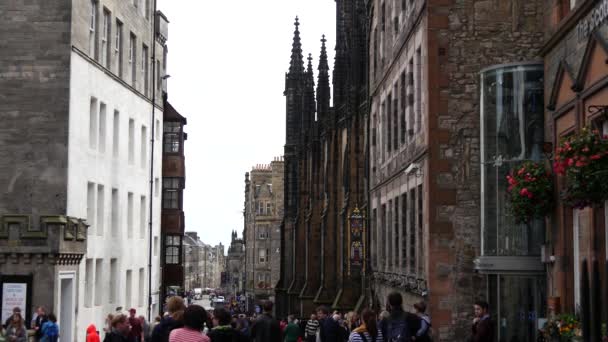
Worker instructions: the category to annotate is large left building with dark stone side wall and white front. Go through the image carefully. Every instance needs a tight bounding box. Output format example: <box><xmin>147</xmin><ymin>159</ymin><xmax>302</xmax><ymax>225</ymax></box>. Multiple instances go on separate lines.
<box><xmin>0</xmin><ymin>0</ymin><xmax>167</xmax><ymax>341</ymax></box>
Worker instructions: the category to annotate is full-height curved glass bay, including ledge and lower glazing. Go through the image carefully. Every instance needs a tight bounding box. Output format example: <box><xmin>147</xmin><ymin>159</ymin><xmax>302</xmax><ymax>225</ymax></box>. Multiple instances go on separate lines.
<box><xmin>476</xmin><ymin>63</ymin><xmax>546</xmax><ymax>342</ymax></box>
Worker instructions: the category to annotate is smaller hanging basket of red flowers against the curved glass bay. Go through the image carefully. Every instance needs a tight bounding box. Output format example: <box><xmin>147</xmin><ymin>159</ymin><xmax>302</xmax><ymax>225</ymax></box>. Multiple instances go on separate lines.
<box><xmin>507</xmin><ymin>161</ymin><xmax>553</xmax><ymax>223</ymax></box>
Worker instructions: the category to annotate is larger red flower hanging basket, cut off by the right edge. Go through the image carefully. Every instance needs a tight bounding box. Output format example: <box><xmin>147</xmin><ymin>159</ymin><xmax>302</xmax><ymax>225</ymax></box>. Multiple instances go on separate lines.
<box><xmin>553</xmin><ymin>128</ymin><xmax>608</xmax><ymax>209</ymax></box>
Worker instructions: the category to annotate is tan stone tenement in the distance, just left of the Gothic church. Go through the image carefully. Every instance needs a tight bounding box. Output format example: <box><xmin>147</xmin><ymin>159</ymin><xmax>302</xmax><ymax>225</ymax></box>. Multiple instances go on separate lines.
<box><xmin>243</xmin><ymin>158</ymin><xmax>284</xmax><ymax>300</ymax></box>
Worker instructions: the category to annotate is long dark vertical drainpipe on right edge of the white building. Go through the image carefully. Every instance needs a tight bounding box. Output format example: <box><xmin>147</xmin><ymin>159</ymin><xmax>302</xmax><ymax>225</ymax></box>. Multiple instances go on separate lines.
<box><xmin>148</xmin><ymin>0</ymin><xmax>158</xmax><ymax>322</ymax></box>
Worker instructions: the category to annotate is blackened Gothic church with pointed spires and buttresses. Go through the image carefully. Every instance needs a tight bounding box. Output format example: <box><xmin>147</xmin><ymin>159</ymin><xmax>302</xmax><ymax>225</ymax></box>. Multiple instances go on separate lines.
<box><xmin>276</xmin><ymin>0</ymin><xmax>367</xmax><ymax>317</ymax></box>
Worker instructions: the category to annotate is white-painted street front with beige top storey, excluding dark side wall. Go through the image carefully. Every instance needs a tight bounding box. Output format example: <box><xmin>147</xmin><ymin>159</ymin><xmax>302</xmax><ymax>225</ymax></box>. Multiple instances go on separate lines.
<box><xmin>67</xmin><ymin>0</ymin><xmax>167</xmax><ymax>341</ymax></box>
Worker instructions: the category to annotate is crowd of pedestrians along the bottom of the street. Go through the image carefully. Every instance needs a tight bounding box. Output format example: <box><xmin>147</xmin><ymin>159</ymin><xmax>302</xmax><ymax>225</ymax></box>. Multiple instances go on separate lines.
<box><xmin>0</xmin><ymin>292</ymin><xmax>494</xmax><ymax>342</ymax></box>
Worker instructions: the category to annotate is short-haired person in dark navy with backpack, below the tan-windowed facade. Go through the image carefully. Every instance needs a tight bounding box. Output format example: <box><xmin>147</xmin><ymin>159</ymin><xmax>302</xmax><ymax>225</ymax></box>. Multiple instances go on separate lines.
<box><xmin>380</xmin><ymin>292</ymin><xmax>420</xmax><ymax>342</ymax></box>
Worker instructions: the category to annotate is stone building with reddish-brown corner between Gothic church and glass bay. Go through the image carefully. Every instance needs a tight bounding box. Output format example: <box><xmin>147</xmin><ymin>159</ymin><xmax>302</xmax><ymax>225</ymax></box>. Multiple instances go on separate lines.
<box><xmin>368</xmin><ymin>0</ymin><xmax>543</xmax><ymax>341</ymax></box>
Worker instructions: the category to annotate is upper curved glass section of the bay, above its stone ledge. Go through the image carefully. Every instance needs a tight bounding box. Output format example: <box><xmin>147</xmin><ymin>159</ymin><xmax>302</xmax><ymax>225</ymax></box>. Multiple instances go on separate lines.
<box><xmin>481</xmin><ymin>65</ymin><xmax>544</xmax><ymax>256</ymax></box>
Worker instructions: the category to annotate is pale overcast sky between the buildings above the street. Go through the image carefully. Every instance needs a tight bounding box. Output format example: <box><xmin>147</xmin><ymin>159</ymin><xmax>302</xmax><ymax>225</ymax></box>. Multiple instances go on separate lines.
<box><xmin>158</xmin><ymin>0</ymin><xmax>336</xmax><ymax>251</ymax></box>
